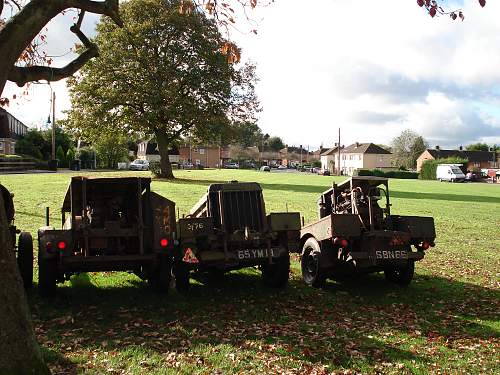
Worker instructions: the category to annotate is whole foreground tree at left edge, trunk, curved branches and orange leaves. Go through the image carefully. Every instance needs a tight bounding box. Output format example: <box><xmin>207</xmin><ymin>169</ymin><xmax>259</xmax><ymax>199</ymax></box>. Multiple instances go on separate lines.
<box><xmin>0</xmin><ymin>0</ymin><xmax>257</xmax><ymax>374</ymax></box>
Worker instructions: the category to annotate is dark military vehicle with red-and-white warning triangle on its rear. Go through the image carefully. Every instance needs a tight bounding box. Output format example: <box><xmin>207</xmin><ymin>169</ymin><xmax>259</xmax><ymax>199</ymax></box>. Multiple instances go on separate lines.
<box><xmin>173</xmin><ymin>181</ymin><xmax>300</xmax><ymax>292</ymax></box>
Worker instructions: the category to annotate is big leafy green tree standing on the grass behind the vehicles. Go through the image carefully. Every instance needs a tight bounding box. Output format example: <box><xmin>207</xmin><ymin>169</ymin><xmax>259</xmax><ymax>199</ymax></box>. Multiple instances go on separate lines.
<box><xmin>67</xmin><ymin>0</ymin><xmax>257</xmax><ymax>178</ymax></box>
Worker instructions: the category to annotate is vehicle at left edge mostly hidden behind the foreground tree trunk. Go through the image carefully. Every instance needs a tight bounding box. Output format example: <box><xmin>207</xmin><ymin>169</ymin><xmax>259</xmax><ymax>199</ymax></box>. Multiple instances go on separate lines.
<box><xmin>0</xmin><ymin>185</ymin><xmax>33</xmax><ymax>290</ymax></box>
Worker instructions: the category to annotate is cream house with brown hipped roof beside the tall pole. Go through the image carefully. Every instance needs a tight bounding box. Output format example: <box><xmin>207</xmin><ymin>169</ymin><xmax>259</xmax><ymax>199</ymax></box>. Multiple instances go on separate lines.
<box><xmin>334</xmin><ymin>142</ymin><xmax>392</xmax><ymax>176</ymax></box>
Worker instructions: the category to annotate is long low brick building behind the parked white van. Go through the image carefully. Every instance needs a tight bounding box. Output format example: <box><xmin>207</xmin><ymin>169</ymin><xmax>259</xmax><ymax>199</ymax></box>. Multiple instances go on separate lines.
<box><xmin>417</xmin><ymin>149</ymin><xmax>499</xmax><ymax>172</ymax></box>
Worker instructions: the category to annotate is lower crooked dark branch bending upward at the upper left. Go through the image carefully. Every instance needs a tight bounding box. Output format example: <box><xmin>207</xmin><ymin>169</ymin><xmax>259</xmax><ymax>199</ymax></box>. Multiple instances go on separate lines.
<box><xmin>8</xmin><ymin>17</ymin><xmax>99</xmax><ymax>87</ymax></box>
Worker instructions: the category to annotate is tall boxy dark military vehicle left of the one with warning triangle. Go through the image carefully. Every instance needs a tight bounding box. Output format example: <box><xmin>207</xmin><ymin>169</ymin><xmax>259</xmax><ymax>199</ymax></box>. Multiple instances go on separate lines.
<box><xmin>38</xmin><ymin>177</ymin><xmax>175</xmax><ymax>295</ymax></box>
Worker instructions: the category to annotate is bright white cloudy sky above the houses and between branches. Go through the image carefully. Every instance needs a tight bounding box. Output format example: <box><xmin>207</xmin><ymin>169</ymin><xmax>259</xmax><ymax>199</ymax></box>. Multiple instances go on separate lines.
<box><xmin>3</xmin><ymin>0</ymin><xmax>500</xmax><ymax>149</ymax></box>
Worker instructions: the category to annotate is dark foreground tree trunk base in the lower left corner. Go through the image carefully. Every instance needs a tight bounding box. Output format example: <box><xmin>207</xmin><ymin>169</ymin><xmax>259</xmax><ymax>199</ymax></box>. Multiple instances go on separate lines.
<box><xmin>0</xmin><ymin>188</ymin><xmax>50</xmax><ymax>375</ymax></box>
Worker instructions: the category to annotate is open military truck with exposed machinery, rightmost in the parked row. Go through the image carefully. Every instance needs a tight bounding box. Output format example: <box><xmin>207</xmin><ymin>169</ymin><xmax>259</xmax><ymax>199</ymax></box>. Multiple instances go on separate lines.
<box><xmin>301</xmin><ymin>177</ymin><xmax>436</xmax><ymax>287</ymax></box>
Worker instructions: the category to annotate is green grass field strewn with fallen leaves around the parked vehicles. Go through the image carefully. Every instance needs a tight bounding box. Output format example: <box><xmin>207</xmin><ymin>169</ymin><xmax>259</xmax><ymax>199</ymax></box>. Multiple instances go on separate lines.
<box><xmin>0</xmin><ymin>170</ymin><xmax>500</xmax><ymax>374</ymax></box>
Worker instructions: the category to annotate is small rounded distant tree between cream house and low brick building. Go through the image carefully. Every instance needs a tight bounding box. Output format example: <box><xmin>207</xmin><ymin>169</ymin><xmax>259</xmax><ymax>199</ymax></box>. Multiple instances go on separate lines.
<box><xmin>391</xmin><ymin>129</ymin><xmax>429</xmax><ymax>169</ymax></box>
